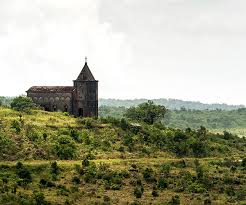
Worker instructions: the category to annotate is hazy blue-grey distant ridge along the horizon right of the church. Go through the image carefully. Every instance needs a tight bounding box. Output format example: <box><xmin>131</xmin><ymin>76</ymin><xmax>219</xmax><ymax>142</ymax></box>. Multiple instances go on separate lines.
<box><xmin>99</xmin><ymin>98</ymin><xmax>245</xmax><ymax>110</ymax></box>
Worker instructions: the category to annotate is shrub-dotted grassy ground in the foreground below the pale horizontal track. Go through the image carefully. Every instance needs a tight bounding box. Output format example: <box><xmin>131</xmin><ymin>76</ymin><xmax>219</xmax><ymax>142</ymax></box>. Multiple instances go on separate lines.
<box><xmin>0</xmin><ymin>158</ymin><xmax>246</xmax><ymax>205</ymax></box>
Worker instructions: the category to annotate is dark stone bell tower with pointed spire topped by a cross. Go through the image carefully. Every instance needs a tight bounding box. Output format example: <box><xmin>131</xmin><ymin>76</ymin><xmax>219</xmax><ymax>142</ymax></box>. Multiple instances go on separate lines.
<box><xmin>73</xmin><ymin>58</ymin><xmax>98</xmax><ymax>117</ymax></box>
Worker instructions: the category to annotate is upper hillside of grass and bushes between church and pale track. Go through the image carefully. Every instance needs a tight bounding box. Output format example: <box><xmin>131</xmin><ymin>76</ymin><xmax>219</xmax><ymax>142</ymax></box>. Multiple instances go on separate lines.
<box><xmin>0</xmin><ymin>107</ymin><xmax>246</xmax><ymax>160</ymax></box>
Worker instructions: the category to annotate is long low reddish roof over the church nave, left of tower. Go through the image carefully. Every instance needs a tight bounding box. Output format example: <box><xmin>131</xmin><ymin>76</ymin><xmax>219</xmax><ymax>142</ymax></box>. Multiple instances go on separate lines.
<box><xmin>27</xmin><ymin>86</ymin><xmax>74</xmax><ymax>93</ymax></box>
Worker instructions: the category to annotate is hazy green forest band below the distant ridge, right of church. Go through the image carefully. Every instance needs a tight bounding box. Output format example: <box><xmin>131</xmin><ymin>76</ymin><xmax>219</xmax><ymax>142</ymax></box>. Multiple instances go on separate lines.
<box><xmin>99</xmin><ymin>106</ymin><xmax>246</xmax><ymax>129</ymax></box>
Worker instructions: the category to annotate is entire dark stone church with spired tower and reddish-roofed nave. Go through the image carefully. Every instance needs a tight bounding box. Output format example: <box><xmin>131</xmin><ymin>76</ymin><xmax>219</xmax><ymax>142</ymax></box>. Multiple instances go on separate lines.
<box><xmin>26</xmin><ymin>60</ymin><xmax>98</xmax><ymax>117</ymax></box>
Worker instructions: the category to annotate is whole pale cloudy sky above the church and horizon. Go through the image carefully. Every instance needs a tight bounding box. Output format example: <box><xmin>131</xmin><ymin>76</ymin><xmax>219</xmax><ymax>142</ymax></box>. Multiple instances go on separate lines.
<box><xmin>0</xmin><ymin>0</ymin><xmax>246</xmax><ymax>105</ymax></box>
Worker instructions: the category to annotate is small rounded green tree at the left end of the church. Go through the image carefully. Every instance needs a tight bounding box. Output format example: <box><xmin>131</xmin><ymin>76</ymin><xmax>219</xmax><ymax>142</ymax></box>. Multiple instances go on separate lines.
<box><xmin>11</xmin><ymin>96</ymin><xmax>35</xmax><ymax>111</ymax></box>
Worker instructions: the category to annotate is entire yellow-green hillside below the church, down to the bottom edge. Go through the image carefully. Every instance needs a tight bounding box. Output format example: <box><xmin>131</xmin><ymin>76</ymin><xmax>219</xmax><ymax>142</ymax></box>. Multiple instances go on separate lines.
<box><xmin>0</xmin><ymin>107</ymin><xmax>246</xmax><ymax>204</ymax></box>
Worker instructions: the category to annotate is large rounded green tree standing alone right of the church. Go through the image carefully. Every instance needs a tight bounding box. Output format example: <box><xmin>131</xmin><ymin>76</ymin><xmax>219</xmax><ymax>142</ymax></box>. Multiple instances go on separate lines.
<box><xmin>125</xmin><ymin>100</ymin><xmax>167</xmax><ymax>124</ymax></box>
